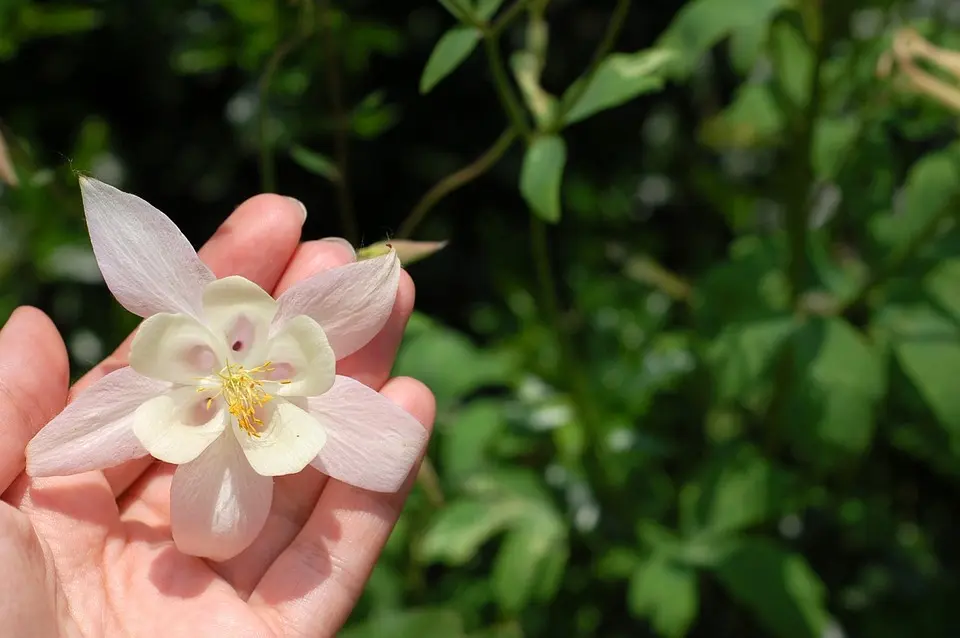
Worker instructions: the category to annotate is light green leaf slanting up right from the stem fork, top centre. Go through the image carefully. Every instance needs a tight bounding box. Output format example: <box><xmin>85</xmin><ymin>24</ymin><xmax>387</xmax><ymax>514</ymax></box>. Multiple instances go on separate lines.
<box><xmin>563</xmin><ymin>49</ymin><xmax>675</xmax><ymax>124</ymax></box>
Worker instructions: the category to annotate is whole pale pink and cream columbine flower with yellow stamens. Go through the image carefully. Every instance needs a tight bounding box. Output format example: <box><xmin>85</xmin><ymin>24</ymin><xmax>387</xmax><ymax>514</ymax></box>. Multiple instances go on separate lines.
<box><xmin>27</xmin><ymin>178</ymin><xmax>426</xmax><ymax>560</ymax></box>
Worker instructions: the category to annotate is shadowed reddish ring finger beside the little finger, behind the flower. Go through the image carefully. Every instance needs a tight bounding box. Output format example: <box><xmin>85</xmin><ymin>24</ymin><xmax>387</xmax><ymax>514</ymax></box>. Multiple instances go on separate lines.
<box><xmin>213</xmin><ymin>251</ymin><xmax>415</xmax><ymax>597</ymax></box>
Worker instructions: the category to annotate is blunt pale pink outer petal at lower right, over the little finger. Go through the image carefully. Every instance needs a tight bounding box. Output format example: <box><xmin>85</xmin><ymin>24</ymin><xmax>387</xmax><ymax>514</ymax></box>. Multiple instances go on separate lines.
<box><xmin>307</xmin><ymin>376</ymin><xmax>427</xmax><ymax>492</ymax></box>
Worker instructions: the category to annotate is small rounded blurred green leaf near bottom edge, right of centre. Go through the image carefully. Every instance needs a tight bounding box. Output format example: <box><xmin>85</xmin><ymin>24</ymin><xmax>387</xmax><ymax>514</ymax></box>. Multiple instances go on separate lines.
<box><xmin>628</xmin><ymin>554</ymin><xmax>699</xmax><ymax>638</ymax></box>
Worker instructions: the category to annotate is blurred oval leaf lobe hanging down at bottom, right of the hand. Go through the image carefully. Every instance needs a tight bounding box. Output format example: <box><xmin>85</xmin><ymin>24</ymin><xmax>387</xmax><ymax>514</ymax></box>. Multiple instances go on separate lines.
<box><xmin>491</xmin><ymin>509</ymin><xmax>568</xmax><ymax>613</ymax></box>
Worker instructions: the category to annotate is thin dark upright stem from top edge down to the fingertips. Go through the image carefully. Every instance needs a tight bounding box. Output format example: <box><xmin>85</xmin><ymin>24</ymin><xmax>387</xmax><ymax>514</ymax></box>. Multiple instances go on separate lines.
<box><xmin>320</xmin><ymin>0</ymin><xmax>360</xmax><ymax>245</ymax></box>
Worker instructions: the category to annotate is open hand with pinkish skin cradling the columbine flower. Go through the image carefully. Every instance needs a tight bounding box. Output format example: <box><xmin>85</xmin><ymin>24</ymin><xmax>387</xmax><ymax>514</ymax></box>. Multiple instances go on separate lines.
<box><xmin>0</xmin><ymin>195</ymin><xmax>435</xmax><ymax>638</ymax></box>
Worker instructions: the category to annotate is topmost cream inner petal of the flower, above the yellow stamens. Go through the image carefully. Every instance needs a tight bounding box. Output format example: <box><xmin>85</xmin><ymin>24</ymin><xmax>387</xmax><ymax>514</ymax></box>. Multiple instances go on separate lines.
<box><xmin>203</xmin><ymin>276</ymin><xmax>277</xmax><ymax>367</ymax></box>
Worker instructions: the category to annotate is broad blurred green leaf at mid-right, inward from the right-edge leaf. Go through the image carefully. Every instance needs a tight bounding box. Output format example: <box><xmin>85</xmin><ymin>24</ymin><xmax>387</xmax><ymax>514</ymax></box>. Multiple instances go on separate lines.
<box><xmin>786</xmin><ymin>318</ymin><xmax>886</xmax><ymax>464</ymax></box>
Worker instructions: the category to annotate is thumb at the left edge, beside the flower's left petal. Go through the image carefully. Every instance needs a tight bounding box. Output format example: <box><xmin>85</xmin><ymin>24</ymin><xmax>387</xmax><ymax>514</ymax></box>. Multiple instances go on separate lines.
<box><xmin>0</xmin><ymin>307</ymin><xmax>70</xmax><ymax>492</ymax></box>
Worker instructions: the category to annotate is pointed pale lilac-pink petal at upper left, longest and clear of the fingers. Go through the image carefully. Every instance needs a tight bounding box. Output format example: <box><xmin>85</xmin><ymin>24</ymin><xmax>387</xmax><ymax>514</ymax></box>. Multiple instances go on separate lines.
<box><xmin>80</xmin><ymin>177</ymin><xmax>214</xmax><ymax>317</ymax></box>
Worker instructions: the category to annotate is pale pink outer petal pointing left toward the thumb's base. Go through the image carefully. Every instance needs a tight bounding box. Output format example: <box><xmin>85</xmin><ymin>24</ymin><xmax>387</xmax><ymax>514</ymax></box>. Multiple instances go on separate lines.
<box><xmin>27</xmin><ymin>368</ymin><xmax>170</xmax><ymax>476</ymax></box>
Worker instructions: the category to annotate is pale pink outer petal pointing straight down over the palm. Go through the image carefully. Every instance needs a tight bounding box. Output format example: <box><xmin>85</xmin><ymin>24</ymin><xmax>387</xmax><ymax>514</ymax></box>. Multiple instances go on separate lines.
<box><xmin>170</xmin><ymin>429</ymin><xmax>273</xmax><ymax>561</ymax></box>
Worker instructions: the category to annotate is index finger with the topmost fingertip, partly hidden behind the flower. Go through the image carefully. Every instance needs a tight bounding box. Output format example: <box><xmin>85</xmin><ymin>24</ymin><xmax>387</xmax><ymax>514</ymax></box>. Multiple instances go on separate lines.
<box><xmin>98</xmin><ymin>195</ymin><xmax>306</xmax><ymax>495</ymax></box>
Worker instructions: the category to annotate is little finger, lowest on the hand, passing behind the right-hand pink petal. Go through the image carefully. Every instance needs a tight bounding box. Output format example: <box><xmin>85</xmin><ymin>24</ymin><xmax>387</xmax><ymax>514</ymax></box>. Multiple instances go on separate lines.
<box><xmin>249</xmin><ymin>378</ymin><xmax>436</xmax><ymax>636</ymax></box>
